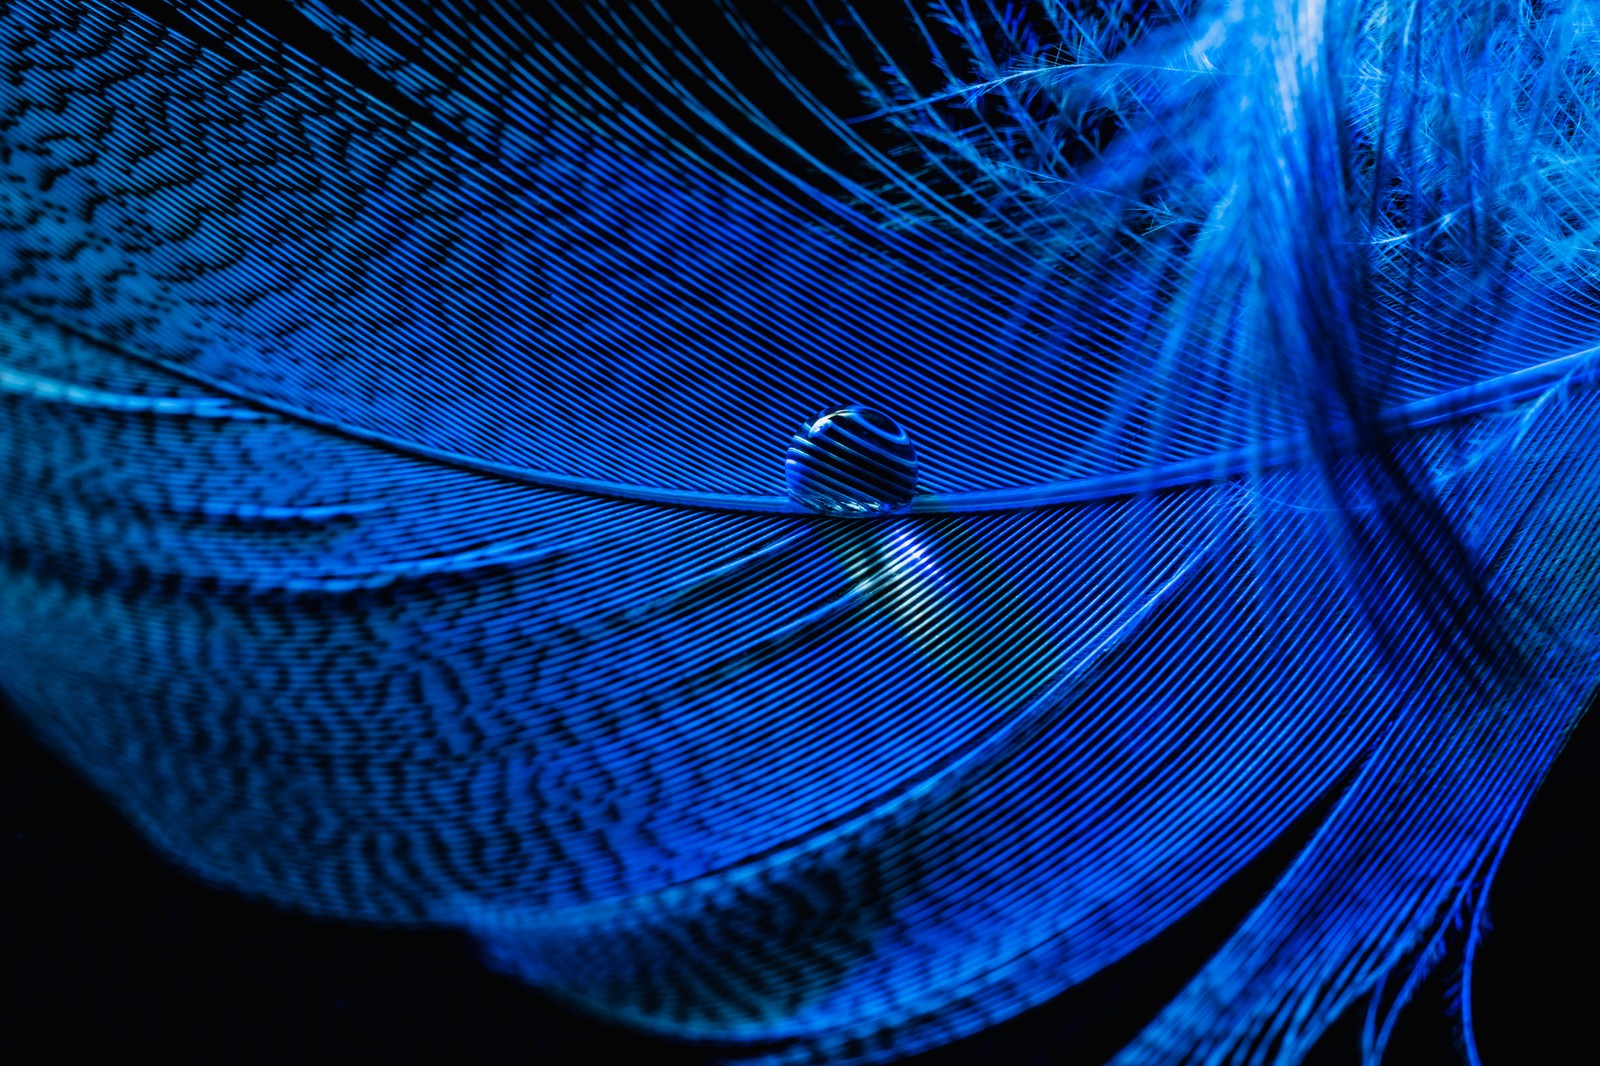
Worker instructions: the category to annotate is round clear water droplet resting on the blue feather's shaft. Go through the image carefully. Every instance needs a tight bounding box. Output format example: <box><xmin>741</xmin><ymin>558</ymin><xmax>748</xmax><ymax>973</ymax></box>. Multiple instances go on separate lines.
<box><xmin>784</xmin><ymin>407</ymin><xmax>917</xmax><ymax>517</ymax></box>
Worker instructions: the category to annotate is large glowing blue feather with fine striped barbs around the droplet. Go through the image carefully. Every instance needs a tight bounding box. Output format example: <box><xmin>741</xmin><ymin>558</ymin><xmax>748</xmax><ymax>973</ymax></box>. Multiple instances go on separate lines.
<box><xmin>0</xmin><ymin>0</ymin><xmax>1600</xmax><ymax>1063</ymax></box>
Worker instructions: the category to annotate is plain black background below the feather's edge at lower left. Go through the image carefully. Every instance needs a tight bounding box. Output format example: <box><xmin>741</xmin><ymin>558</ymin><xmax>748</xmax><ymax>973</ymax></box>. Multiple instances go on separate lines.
<box><xmin>0</xmin><ymin>712</ymin><xmax>704</xmax><ymax>1066</ymax></box>
